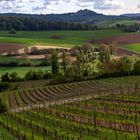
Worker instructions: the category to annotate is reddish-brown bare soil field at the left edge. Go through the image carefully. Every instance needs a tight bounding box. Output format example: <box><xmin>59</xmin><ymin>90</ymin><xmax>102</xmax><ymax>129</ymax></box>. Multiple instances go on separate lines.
<box><xmin>0</xmin><ymin>43</ymin><xmax>25</xmax><ymax>54</ymax></box>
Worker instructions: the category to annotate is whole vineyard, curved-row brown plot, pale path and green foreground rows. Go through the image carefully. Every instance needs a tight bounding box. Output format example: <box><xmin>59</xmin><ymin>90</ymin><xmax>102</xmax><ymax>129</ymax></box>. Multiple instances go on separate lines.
<box><xmin>0</xmin><ymin>81</ymin><xmax>140</xmax><ymax>140</ymax></box>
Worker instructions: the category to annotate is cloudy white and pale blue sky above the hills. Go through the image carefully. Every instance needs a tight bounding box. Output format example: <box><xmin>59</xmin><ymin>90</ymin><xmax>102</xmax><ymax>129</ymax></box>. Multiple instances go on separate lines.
<box><xmin>0</xmin><ymin>0</ymin><xmax>140</xmax><ymax>15</ymax></box>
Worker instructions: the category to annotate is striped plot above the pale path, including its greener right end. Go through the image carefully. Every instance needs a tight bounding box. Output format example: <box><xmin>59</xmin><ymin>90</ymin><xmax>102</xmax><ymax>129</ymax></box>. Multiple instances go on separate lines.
<box><xmin>8</xmin><ymin>76</ymin><xmax>140</xmax><ymax>109</ymax></box>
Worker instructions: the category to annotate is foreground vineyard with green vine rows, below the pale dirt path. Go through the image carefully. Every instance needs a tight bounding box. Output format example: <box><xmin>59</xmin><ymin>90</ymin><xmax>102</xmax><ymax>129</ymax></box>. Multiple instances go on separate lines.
<box><xmin>0</xmin><ymin>87</ymin><xmax>140</xmax><ymax>140</ymax></box>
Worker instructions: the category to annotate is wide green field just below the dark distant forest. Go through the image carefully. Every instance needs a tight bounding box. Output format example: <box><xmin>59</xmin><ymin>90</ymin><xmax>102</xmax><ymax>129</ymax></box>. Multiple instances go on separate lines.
<box><xmin>0</xmin><ymin>30</ymin><xmax>127</xmax><ymax>47</ymax></box>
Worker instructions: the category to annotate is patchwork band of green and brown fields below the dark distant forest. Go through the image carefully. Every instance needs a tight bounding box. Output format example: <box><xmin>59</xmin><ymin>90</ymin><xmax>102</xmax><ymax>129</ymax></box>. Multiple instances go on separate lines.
<box><xmin>0</xmin><ymin>30</ymin><xmax>140</xmax><ymax>59</ymax></box>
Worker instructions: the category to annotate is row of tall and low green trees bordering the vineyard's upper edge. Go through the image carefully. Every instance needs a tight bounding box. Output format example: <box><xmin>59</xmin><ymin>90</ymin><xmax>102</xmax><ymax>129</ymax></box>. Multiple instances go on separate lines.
<box><xmin>1</xmin><ymin>44</ymin><xmax>140</xmax><ymax>84</ymax></box>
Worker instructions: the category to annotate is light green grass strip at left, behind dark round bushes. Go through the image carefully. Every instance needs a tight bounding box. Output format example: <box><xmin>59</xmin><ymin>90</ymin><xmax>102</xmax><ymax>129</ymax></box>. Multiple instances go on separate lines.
<box><xmin>0</xmin><ymin>67</ymin><xmax>51</xmax><ymax>77</ymax></box>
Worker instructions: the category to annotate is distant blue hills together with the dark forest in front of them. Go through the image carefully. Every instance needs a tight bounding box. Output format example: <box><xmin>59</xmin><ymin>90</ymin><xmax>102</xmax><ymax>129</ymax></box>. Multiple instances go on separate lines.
<box><xmin>0</xmin><ymin>10</ymin><xmax>132</xmax><ymax>31</ymax></box>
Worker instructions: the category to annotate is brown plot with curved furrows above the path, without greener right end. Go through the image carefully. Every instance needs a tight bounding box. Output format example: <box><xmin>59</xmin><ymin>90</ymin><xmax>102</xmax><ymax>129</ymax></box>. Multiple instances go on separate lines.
<box><xmin>8</xmin><ymin>81</ymin><xmax>117</xmax><ymax>109</ymax></box>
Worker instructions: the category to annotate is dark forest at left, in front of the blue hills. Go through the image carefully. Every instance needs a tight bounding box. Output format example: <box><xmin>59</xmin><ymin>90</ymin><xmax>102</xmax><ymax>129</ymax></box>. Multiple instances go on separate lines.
<box><xmin>0</xmin><ymin>16</ymin><xmax>97</xmax><ymax>31</ymax></box>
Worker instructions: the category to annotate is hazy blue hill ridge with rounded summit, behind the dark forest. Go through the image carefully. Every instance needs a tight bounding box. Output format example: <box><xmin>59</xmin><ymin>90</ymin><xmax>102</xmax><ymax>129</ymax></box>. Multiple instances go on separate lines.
<box><xmin>1</xmin><ymin>9</ymin><xmax>128</xmax><ymax>24</ymax></box>
